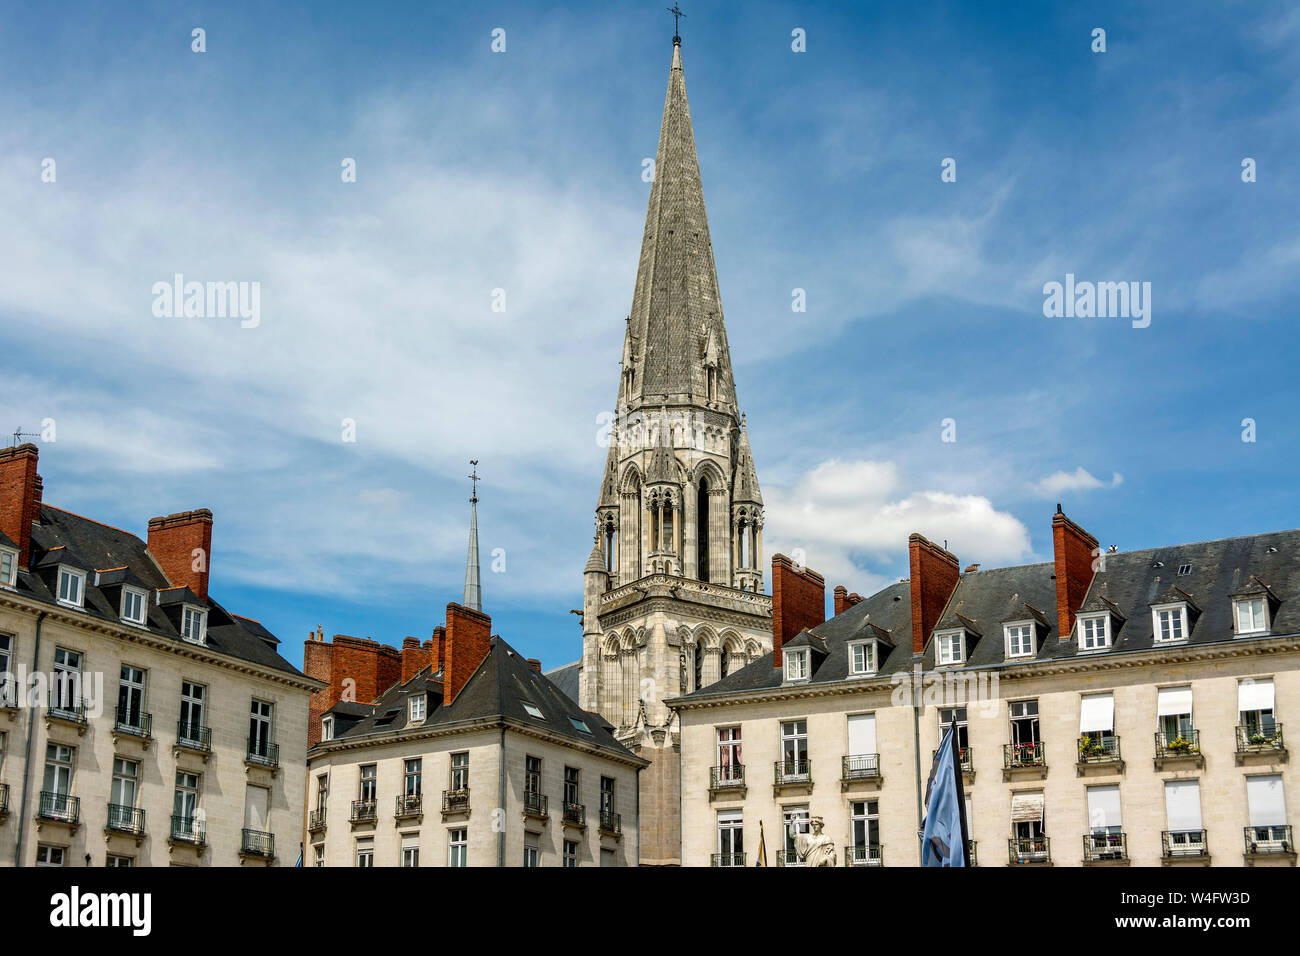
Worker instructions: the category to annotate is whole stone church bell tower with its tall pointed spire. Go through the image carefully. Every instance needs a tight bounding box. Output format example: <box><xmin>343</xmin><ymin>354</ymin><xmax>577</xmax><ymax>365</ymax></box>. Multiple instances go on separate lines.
<box><xmin>579</xmin><ymin>36</ymin><xmax>772</xmax><ymax>865</ymax></box>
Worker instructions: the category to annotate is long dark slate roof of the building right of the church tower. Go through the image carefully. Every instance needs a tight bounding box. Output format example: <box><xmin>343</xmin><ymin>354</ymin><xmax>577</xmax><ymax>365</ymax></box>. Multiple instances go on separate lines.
<box><xmin>681</xmin><ymin>531</ymin><xmax>1300</xmax><ymax>700</ymax></box>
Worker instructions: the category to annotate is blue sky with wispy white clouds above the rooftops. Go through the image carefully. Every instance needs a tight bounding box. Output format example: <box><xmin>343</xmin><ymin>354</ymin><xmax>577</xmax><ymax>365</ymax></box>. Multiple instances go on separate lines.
<box><xmin>0</xmin><ymin>3</ymin><xmax>1300</xmax><ymax>666</ymax></box>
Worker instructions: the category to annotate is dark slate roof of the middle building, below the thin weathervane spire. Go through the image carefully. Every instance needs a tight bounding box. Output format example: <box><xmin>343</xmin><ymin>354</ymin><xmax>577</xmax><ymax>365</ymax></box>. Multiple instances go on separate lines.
<box><xmin>322</xmin><ymin>637</ymin><xmax>636</xmax><ymax>760</ymax></box>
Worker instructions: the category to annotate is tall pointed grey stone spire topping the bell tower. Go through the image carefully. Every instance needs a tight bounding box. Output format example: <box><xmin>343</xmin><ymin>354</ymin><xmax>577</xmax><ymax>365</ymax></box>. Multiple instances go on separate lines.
<box><xmin>619</xmin><ymin>43</ymin><xmax>737</xmax><ymax>415</ymax></box>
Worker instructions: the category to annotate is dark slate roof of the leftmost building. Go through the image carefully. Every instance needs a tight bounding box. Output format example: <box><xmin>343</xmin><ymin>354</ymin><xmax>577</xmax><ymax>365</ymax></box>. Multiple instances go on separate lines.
<box><xmin>3</xmin><ymin>503</ymin><xmax>302</xmax><ymax>676</ymax></box>
